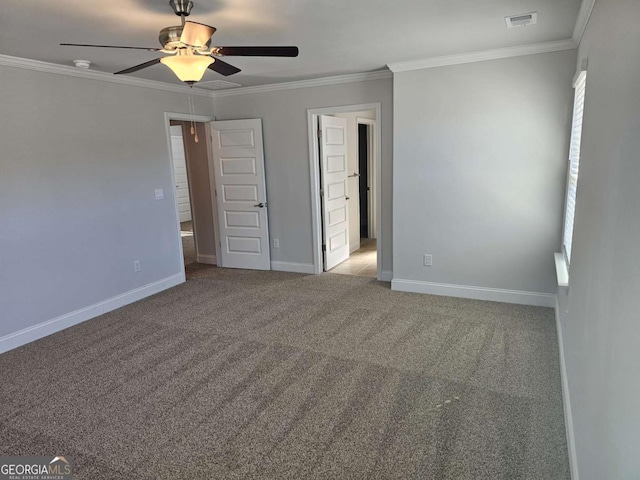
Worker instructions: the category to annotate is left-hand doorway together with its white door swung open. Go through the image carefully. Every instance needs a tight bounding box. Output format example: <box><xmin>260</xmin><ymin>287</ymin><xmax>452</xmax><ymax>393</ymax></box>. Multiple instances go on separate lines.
<box><xmin>165</xmin><ymin>113</ymin><xmax>271</xmax><ymax>278</ymax></box>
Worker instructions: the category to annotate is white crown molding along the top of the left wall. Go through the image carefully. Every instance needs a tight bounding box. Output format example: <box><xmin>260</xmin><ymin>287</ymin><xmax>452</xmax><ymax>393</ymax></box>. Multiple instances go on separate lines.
<box><xmin>0</xmin><ymin>55</ymin><xmax>214</xmax><ymax>98</ymax></box>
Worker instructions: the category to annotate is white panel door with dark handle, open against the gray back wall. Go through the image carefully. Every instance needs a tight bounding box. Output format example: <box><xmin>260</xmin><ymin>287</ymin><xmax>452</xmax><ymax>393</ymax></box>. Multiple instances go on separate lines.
<box><xmin>211</xmin><ymin>118</ymin><xmax>271</xmax><ymax>270</ymax></box>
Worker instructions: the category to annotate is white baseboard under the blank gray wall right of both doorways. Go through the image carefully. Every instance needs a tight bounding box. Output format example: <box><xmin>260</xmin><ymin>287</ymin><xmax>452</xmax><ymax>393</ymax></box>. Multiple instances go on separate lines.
<box><xmin>391</xmin><ymin>278</ymin><xmax>556</xmax><ymax>308</ymax></box>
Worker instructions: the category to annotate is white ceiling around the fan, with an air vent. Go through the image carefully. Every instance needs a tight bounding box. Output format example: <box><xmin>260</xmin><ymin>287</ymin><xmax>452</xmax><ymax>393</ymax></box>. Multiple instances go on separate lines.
<box><xmin>0</xmin><ymin>0</ymin><xmax>581</xmax><ymax>86</ymax></box>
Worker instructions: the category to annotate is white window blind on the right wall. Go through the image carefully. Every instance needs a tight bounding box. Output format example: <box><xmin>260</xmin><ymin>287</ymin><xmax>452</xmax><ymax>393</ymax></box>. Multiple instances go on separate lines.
<box><xmin>563</xmin><ymin>71</ymin><xmax>587</xmax><ymax>263</ymax></box>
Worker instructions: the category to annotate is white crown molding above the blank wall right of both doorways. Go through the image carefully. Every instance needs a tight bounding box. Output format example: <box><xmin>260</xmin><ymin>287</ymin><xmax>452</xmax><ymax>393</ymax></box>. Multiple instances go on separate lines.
<box><xmin>387</xmin><ymin>39</ymin><xmax>577</xmax><ymax>73</ymax></box>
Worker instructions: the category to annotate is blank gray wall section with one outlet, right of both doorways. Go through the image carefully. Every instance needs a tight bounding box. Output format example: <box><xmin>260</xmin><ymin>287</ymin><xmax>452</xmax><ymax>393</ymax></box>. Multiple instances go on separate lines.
<box><xmin>393</xmin><ymin>51</ymin><xmax>576</xmax><ymax>293</ymax></box>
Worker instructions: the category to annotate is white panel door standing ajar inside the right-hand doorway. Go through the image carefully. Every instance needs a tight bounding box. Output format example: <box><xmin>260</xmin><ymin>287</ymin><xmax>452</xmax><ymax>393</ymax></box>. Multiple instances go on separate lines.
<box><xmin>318</xmin><ymin>115</ymin><xmax>349</xmax><ymax>271</ymax></box>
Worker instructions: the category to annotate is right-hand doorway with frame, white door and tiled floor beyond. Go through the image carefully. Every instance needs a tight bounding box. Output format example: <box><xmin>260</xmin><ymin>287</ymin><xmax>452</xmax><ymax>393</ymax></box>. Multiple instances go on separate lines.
<box><xmin>308</xmin><ymin>104</ymin><xmax>381</xmax><ymax>278</ymax></box>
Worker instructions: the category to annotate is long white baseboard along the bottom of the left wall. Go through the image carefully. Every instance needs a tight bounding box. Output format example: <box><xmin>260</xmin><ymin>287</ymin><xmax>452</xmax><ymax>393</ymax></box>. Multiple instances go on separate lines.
<box><xmin>0</xmin><ymin>272</ymin><xmax>185</xmax><ymax>353</ymax></box>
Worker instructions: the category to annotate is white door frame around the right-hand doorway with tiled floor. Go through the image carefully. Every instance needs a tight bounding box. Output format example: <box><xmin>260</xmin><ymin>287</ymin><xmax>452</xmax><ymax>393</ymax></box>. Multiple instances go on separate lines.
<box><xmin>307</xmin><ymin>103</ymin><xmax>382</xmax><ymax>280</ymax></box>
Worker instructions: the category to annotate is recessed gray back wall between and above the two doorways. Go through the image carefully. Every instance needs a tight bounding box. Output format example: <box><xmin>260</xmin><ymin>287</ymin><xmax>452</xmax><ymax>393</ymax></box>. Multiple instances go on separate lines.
<box><xmin>215</xmin><ymin>79</ymin><xmax>393</xmax><ymax>271</ymax></box>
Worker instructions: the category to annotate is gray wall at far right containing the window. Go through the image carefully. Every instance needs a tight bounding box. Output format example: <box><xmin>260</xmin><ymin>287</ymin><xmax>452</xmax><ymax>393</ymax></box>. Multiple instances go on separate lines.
<box><xmin>557</xmin><ymin>0</ymin><xmax>640</xmax><ymax>480</ymax></box>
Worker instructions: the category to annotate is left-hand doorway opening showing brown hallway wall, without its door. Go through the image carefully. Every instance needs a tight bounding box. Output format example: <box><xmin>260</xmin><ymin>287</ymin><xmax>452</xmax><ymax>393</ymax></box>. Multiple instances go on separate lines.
<box><xmin>168</xmin><ymin>116</ymin><xmax>217</xmax><ymax>278</ymax></box>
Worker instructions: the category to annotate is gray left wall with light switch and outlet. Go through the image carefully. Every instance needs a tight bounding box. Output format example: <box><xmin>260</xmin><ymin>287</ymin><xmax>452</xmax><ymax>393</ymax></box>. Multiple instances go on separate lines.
<box><xmin>0</xmin><ymin>66</ymin><xmax>213</xmax><ymax>337</ymax></box>
